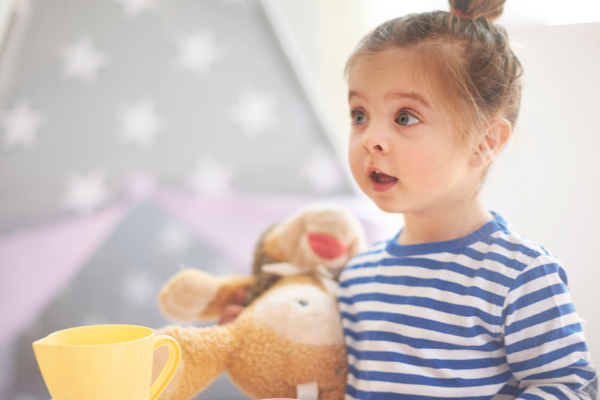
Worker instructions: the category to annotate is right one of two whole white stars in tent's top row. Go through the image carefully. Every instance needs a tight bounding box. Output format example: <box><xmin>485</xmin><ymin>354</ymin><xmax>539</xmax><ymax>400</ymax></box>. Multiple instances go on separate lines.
<box><xmin>176</xmin><ymin>32</ymin><xmax>222</xmax><ymax>75</ymax></box>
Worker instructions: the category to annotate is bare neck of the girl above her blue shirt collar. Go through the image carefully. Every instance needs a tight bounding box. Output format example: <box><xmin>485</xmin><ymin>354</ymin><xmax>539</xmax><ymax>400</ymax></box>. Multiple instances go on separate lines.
<box><xmin>398</xmin><ymin>196</ymin><xmax>494</xmax><ymax>245</ymax></box>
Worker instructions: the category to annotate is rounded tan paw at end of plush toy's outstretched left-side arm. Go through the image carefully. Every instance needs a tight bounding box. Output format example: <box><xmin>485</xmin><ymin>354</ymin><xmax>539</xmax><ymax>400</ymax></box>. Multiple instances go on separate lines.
<box><xmin>158</xmin><ymin>269</ymin><xmax>219</xmax><ymax>322</ymax></box>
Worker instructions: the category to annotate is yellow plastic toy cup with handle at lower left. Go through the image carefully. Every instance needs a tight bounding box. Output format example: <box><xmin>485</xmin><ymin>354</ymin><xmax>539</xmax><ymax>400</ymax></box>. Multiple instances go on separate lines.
<box><xmin>33</xmin><ymin>325</ymin><xmax>181</xmax><ymax>400</ymax></box>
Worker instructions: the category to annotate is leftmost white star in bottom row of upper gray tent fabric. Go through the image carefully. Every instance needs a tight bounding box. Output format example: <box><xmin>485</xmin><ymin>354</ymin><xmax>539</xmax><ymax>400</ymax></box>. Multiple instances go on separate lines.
<box><xmin>64</xmin><ymin>171</ymin><xmax>109</xmax><ymax>213</ymax></box>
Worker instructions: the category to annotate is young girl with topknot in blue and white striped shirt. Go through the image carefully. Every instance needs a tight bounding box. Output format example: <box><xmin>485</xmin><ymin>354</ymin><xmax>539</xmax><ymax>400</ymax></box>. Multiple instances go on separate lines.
<box><xmin>339</xmin><ymin>0</ymin><xmax>597</xmax><ymax>400</ymax></box>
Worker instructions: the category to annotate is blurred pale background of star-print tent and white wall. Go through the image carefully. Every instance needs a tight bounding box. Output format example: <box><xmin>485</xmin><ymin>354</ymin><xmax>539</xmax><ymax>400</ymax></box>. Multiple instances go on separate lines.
<box><xmin>0</xmin><ymin>0</ymin><xmax>600</xmax><ymax>400</ymax></box>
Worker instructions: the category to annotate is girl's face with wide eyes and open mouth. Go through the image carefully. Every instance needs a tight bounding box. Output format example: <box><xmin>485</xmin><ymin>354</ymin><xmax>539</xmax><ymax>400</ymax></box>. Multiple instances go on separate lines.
<box><xmin>348</xmin><ymin>49</ymin><xmax>478</xmax><ymax>213</ymax></box>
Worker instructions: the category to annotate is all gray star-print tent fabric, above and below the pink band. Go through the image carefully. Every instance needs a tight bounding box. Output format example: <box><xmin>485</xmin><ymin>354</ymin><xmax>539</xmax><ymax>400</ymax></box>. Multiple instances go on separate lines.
<box><xmin>0</xmin><ymin>0</ymin><xmax>352</xmax><ymax>400</ymax></box>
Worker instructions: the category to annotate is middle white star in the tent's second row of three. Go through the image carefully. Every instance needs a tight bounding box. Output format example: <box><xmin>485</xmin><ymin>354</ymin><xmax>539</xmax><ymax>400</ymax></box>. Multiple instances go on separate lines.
<box><xmin>118</xmin><ymin>98</ymin><xmax>165</xmax><ymax>147</ymax></box>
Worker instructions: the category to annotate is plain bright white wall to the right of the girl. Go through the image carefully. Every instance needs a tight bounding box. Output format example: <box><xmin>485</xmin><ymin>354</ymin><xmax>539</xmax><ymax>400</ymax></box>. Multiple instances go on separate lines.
<box><xmin>484</xmin><ymin>23</ymin><xmax>600</xmax><ymax>363</ymax></box>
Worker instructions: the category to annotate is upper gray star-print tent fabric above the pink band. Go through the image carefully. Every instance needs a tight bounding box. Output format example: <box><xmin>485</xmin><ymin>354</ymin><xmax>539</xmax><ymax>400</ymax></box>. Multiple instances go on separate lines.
<box><xmin>0</xmin><ymin>0</ymin><xmax>351</xmax><ymax>234</ymax></box>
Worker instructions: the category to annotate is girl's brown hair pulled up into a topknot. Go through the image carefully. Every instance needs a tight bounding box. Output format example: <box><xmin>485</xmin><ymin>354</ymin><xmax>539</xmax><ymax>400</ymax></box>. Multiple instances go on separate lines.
<box><xmin>346</xmin><ymin>0</ymin><xmax>522</xmax><ymax>162</ymax></box>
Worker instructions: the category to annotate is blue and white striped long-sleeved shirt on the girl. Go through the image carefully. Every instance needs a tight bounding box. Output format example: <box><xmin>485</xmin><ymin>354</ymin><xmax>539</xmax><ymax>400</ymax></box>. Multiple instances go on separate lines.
<box><xmin>339</xmin><ymin>213</ymin><xmax>597</xmax><ymax>400</ymax></box>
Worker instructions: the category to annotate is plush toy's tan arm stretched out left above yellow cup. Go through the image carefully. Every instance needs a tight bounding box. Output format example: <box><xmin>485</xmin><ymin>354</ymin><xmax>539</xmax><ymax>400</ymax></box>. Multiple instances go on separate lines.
<box><xmin>158</xmin><ymin>268</ymin><xmax>255</xmax><ymax>322</ymax></box>
